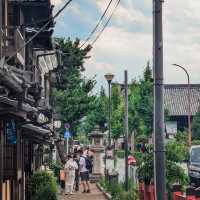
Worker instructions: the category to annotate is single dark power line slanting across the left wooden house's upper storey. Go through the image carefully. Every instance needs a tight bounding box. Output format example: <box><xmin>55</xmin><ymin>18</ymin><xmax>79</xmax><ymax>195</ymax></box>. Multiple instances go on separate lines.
<box><xmin>6</xmin><ymin>0</ymin><xmax>72</xmax><ymax>62</ymax></box>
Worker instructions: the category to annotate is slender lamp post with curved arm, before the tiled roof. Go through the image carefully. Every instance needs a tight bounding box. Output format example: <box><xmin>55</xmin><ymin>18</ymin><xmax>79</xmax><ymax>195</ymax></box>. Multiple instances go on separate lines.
<box><xmin>173</xmin><ymin>64</ymin><xmax>192</xmax><ymax>147</ymax></box>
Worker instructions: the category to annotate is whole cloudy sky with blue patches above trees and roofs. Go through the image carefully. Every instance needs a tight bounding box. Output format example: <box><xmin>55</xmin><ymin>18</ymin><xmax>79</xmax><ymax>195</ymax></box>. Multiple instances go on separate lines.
<box><xmin>52</xmin><ymin>0</ymin><xmax>200</xmax><ymax>91</ymax></box>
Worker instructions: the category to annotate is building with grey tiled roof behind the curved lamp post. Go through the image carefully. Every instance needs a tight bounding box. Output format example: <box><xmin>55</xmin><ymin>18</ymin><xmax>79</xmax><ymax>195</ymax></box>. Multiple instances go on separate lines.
<box><xmin>164</xmin><ymin>84</ymin><xmax>200</xmax><ymax>134</ymax></box>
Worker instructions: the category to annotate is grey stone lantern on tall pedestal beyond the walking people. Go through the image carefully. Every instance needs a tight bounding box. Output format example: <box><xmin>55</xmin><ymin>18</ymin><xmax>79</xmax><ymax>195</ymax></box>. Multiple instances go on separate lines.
<box><xmin>89</xmin><ymin>126</ymin><xmax>106</xmax><ymax>177</ymax></box>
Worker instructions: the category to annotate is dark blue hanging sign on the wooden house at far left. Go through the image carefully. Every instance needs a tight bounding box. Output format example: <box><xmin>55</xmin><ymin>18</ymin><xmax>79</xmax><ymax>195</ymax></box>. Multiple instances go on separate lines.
<box><xmin>6</xmin><ymin>119</ymin><xmax>17</xmax><ymax>144</ymax></box>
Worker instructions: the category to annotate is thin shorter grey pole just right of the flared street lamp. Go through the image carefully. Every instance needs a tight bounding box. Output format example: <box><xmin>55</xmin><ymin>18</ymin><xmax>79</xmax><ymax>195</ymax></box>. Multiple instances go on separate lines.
<box><xmin>124</xmin><ymin>70</ymin><xmax>128</xmax><ymax>191</ymax></box>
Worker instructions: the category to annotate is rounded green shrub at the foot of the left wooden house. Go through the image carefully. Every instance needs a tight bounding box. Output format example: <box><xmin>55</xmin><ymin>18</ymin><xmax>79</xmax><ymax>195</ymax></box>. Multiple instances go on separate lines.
<box><xmin>31</xmin><ymin>171</ymin><xmax>57</xmax><ymax>200</ymax></box>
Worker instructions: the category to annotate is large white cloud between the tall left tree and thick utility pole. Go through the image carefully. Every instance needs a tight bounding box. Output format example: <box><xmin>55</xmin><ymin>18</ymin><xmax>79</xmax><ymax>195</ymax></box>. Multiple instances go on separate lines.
<box><xmin>85</xmin><ymin>27</ymin><xmax>152</xmax><ymax>85</ymax></box>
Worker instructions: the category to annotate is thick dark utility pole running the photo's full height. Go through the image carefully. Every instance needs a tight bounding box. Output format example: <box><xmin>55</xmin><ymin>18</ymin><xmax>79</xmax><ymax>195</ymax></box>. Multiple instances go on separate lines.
<box><xmin>153</xmin><ymin>0</ymin><xmax>165</xmax><ymax>200</ymax></box>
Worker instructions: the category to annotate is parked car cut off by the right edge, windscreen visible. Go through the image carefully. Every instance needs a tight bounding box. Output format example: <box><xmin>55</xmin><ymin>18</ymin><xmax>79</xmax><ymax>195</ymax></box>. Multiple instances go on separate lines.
<box><xmin>188</xmin><ymin>145</ymin><xmax>200</xmax><ymax>187</ymax></box>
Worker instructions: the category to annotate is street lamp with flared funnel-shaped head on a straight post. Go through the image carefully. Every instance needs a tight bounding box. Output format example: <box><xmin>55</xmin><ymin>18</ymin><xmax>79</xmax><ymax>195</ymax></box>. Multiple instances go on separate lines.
<box><xmin>104</xmin><ymin>73</ymin><xmax>114</xmax><ymax>146</ymax></box>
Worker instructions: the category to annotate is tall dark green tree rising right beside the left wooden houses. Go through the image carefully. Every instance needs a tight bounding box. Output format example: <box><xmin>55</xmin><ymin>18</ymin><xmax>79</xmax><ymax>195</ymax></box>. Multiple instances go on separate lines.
<box><xmin>53</xmin><ymin>38</ymin><xmax>95</xmax><ymax>134</ymax></box>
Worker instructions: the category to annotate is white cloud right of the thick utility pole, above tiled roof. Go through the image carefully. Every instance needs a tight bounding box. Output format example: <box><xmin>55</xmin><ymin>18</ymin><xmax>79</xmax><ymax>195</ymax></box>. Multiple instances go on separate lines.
<box><xmin>164</xmin><ymin>0</ymin><xmax>200</xmax><ymax>83</ymax></box>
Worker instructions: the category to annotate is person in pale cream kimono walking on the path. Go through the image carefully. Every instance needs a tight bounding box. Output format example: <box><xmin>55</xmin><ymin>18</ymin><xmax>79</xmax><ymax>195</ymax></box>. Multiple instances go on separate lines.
<box><xmin>65</xmin><ymin>155</ymin><xmax>78</xmax><ymax>195</ymax></box>
